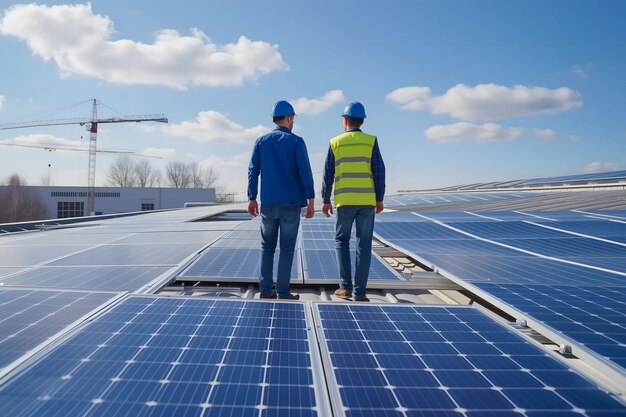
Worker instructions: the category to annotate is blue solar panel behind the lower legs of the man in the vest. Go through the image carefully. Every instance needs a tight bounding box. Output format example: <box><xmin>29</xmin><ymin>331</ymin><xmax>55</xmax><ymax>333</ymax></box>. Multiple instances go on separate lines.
<box><xmin>303</xmin><ymin>249</ymin><xmax>402</xmax><ymax>283</ymax></box>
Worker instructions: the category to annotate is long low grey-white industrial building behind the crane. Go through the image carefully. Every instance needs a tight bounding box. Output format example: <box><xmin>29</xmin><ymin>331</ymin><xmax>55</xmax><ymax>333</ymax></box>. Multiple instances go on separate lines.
<box><xmin>0</xmin><ymin>186</ymin><xmax>216</xmax><ymax>219</ymax></box>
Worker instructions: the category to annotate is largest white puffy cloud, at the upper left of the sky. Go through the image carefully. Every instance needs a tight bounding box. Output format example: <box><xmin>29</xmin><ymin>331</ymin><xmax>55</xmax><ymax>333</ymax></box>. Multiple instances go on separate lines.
<box><xmin>0</xmin><ymin>3</ymin><xmax>288</xmax><ymax>89</ymax></box>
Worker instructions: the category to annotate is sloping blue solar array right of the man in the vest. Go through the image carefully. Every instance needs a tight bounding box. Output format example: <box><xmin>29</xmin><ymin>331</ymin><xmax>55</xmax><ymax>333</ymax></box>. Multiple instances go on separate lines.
<box><xmin>375</xmin><ymin>212</ymin><xmax>626</xmax><ymax>378</ymax></box>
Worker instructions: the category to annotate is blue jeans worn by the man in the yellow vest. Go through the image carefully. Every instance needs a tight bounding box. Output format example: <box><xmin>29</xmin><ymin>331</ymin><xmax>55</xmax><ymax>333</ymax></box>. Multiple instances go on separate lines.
<box><xmin>335</xmin><ymin>206</ymin><xmax>374</xmax><ymax>297</ymax></box>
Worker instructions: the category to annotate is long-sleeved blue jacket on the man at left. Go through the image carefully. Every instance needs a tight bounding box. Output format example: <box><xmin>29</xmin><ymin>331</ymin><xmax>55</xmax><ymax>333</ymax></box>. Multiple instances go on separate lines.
<box><xmin>248</xmin><ymin>126</ymin><xmax>315</xmax><ymax>207</ymax></box>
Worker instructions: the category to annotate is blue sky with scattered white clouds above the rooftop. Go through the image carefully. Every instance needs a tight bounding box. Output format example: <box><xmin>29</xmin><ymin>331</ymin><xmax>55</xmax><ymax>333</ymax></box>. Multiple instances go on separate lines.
<box><xmin>0</xmin><ymin>0</ymin><xmax>626</xmax><ymax>198</ymax></box>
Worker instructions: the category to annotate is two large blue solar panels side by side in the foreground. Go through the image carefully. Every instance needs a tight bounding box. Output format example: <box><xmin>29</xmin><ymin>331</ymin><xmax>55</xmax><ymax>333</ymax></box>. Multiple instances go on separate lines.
<box><xmin>0</xmin><ymin>296</ymin><xmax>626</xmax><ymax>417</ymax></box>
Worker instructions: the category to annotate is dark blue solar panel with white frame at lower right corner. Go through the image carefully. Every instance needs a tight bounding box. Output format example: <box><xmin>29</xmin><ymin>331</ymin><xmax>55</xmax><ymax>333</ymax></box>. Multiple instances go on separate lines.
<box><xmin>473</xmin><ymin>283</ymin><xmax>626</xmax><ymax>389</ymax></box>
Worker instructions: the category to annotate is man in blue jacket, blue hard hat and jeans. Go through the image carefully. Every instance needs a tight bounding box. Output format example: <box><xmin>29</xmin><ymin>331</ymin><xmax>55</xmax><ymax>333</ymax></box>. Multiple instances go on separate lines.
<box><xmin>248</xmin><ymin>100</ymin><xmax>315</xmax><ymax>300</ymax></box>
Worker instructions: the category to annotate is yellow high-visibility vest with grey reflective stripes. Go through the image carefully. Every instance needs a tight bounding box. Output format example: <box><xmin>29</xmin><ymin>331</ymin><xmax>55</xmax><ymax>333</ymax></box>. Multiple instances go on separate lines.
<box><xmin>330</xmin><ymin>131</ymin><xmax>376</xmax><ymax>207</ymax></box>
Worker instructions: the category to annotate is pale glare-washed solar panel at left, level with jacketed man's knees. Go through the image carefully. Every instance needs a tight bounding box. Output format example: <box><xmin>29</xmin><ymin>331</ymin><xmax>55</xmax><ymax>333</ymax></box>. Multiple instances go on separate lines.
<box><xmin>49</xmin><ymin>243</ymin><xmax>204</xmax><ymax>266</ymax></box>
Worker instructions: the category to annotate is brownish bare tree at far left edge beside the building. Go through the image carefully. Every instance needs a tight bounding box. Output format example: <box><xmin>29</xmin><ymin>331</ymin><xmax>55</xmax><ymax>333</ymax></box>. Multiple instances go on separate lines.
<box><xmin>0</xmin><ymin>174</ymin><xmax>47</xmax><ymax>223</ymax></box>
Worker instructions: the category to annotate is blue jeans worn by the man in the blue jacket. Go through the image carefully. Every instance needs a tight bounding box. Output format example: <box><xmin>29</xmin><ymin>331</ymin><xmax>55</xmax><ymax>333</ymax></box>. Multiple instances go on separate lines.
<box><xmin>259</xmin><ymin>204</ymin><xmax>300</xmax><ymax>295</ymax></box>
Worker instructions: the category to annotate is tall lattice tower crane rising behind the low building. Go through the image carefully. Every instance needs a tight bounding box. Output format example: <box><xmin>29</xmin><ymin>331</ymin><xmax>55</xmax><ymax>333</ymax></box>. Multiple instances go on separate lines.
<box><xmin>0</xmin><ymin>98</ymin><xmax>167</xmax><ymax>216</ymax></box>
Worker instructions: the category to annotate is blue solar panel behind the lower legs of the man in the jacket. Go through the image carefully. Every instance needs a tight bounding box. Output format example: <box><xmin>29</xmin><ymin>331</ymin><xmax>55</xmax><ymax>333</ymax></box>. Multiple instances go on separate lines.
<box><xmin>178</xmin><ymin>247</ymin><xmax>300</xmax><ymax>282</ymax></box>
